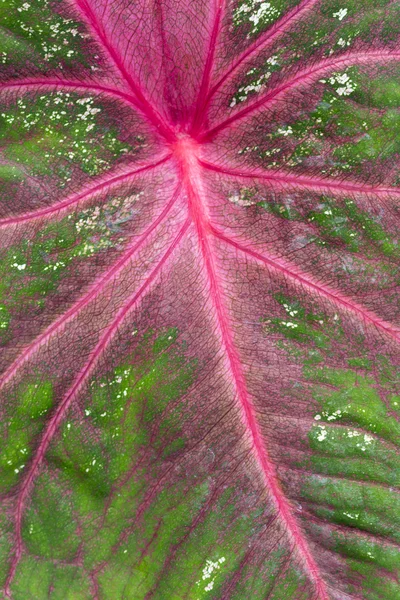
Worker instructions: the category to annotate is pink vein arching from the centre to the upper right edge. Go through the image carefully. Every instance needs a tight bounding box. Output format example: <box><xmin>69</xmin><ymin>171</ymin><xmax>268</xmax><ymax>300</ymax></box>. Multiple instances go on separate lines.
<box><xmin>199</xmin><ymin>51</ymin><xmax>400</xmax><ymax>142</ymax></box>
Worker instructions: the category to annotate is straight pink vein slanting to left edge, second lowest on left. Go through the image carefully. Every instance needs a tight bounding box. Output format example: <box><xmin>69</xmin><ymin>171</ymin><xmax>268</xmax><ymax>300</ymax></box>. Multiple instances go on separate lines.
<box><xmin>0</xmin><ymin>187</ymin><xmax>179</xmax><ymax>389</ymax></box>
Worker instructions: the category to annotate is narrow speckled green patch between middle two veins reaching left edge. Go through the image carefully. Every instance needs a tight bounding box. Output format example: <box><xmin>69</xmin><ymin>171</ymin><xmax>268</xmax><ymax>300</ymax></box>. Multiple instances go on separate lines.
<box><xmin>0</xmin><ymin>194</ymin><xmax>140</xmax><ymax>343</ymax></box>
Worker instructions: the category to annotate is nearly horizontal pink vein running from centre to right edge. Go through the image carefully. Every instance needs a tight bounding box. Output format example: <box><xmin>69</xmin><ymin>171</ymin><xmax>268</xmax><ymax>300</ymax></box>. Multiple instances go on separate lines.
<box><xmin>199</xmin><ymin>160</ymin><xmax>400</xmax><ymax>196</ymax></box>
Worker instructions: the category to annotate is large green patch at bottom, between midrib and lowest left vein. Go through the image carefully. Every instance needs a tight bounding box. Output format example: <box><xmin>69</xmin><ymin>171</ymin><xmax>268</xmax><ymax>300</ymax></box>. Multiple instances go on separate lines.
<box><xmin>10</xmin><ymin>329</ymin><xmax>288</xmax><ymax>600</ymax></box>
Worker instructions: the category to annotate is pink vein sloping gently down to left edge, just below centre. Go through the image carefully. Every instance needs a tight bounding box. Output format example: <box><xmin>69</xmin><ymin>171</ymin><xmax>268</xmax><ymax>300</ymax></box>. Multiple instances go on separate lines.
<box><xmin>0</xmin><ymin>155</ymin><xmax>170</xmax><ymax>227</ymax></box>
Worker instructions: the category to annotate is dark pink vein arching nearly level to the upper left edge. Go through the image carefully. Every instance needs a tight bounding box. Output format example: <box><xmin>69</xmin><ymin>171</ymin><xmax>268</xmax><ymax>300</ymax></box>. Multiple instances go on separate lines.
<box><xmin>0</xmin><ymin>77</ymin><xmax>140</xmax><ymax>108</ymax></box>
